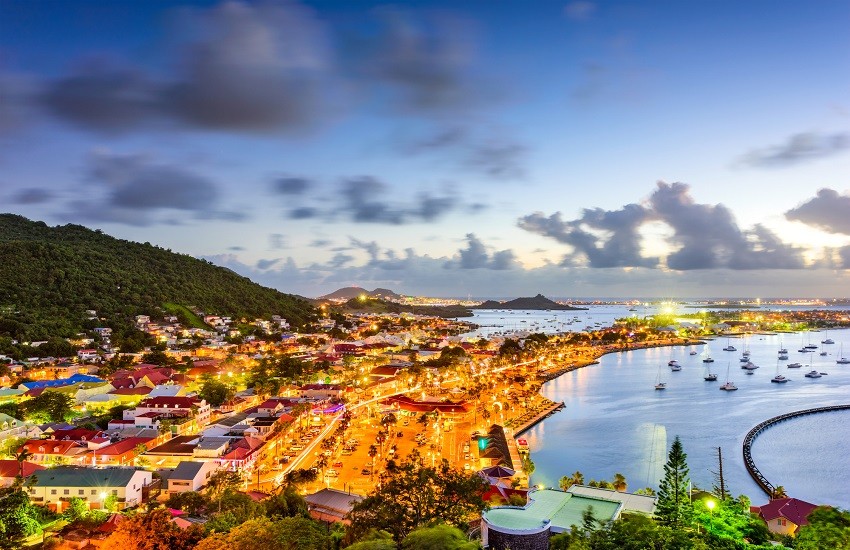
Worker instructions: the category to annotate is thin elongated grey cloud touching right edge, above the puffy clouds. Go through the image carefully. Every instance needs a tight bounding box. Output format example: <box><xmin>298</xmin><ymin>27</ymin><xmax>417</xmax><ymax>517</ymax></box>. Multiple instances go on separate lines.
<box><xmin>738</xmin><ymin>132</ymin><xmax>850</xmax><ymax>168</ymax></box>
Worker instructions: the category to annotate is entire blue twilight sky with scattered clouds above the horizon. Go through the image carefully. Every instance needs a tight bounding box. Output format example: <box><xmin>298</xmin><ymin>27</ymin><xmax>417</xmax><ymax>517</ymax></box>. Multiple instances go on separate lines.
<box><xmin>0</xmin><ymin>0</ymin><xmax>850</xmax><ymax>298</ymax></box>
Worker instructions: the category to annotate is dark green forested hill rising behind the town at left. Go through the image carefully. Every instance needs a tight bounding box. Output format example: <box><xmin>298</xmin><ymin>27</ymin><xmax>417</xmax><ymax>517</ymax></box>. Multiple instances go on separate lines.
<box><xmin>0</xmin><ymin>214</ymin><xmax>315</xmax><ymax>340</ymax></box>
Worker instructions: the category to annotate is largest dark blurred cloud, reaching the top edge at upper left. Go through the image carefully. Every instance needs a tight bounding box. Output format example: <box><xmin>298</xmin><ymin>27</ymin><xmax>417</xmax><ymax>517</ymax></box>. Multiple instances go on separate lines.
<box><xmin>40</xmin><ymin>2</ymin><xmax>332</xmax><ymax>133</ymax></box>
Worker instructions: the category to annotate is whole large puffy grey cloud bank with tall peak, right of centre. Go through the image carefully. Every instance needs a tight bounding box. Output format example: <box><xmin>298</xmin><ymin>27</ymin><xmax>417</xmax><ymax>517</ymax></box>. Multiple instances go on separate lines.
<box><xmin>518</xmin><ymin>182</ymin><xmax>804</xmax><ymax>271</ymax></box>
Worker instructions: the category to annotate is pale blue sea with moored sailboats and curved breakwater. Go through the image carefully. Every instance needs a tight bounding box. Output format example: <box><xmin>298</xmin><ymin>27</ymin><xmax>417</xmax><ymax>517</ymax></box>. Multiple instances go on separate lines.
<box><xmin>454</xmin><ymin>305</ymin><xmax>850</xmax><ymax>509</ymax></box>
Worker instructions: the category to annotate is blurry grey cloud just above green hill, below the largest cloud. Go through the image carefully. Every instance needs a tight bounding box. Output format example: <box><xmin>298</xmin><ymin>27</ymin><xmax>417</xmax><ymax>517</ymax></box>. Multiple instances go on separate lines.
<box><xmin>62</xmin><ymin>152</ymin><xmax>248</xmax><ymax>226</ymax></box>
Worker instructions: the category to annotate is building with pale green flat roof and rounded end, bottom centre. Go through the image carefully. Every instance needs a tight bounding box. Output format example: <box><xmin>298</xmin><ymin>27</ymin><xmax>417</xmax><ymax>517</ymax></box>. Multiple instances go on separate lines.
<box><xmin>481</xmin><ymin>489</ymin><xmax>623</xmax><ymax>550</ymax></box>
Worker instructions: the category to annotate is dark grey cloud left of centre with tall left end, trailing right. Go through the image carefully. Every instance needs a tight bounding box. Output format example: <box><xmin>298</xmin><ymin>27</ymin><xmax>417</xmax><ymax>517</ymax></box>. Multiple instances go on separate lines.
<box><xmin>337</xmin><ymin>176</ymin><xmax>457</xmax><ymax>225</ymax></box>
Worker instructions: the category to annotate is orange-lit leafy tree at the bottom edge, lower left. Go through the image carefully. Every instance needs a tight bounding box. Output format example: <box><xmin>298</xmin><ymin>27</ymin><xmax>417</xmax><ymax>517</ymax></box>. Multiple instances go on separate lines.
<box><xmin>101</xmin><ymin>508</ymin><xmax>204</xmax><ymax>550</ymax></box>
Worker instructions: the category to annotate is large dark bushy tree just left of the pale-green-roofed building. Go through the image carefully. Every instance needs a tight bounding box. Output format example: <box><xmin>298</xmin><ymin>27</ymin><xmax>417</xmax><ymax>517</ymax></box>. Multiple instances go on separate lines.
<box><xmin>348</xmin><ymin>449</ymin><xmax>487</xmax><ymax>541</ymax></box>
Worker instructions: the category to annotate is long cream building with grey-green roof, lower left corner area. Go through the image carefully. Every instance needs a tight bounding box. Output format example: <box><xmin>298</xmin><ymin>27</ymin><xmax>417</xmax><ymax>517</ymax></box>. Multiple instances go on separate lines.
<box><xmin>28</xmin><ymin>466</ymin><xmax>153</xmax><ymax>512</ymax></box>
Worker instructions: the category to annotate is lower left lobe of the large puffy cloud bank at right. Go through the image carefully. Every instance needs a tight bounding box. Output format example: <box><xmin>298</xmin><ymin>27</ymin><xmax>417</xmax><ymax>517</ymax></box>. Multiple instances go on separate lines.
<box><xmin>518</xmin><ymin>204</ymin><xmax>658</xmax><ymax>268</ymax></box>
